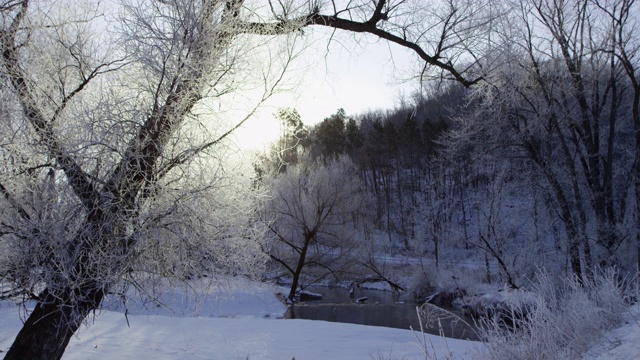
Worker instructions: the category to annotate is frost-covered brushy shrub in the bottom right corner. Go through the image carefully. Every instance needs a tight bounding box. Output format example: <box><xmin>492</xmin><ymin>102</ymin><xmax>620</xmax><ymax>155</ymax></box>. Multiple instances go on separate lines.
<box><xmin>478</xmin><ymin>270</ymin><xmax>628</xmax><ymax>360</ymax></box>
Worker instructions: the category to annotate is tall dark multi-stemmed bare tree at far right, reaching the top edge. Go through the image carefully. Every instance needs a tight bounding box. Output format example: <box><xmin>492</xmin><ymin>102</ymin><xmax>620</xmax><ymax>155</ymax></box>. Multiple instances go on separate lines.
<box><xmin>456</xmin><ymin>1</ymin><xmax>637</xmax><ymax>276</ymax></box>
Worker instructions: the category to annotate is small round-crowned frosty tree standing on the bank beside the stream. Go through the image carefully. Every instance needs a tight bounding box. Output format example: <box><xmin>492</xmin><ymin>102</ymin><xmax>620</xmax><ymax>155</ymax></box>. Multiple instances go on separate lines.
<box><xmin>261</xmin><ymin>156</ymin><xmax>366</xmax><ymax>301</ymax></box>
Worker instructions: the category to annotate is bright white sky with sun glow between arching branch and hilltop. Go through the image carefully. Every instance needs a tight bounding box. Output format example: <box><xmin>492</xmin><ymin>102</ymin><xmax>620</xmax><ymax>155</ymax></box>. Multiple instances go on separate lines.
<box><xmin>237</xmin><ymin>27</ymin><xmax>418</xmax><ymax>148</ymax></box>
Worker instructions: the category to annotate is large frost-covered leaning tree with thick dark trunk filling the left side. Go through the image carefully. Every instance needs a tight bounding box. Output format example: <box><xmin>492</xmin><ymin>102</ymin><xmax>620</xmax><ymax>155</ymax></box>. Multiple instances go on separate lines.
<box><xmin>0</xmin><ymin>0</ymin><xmax>302</xmax><ymax>359</ymax></box>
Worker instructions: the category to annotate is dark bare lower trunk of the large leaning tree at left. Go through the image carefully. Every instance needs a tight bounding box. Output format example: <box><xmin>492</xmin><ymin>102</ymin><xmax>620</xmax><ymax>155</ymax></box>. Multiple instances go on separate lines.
<box><xmin>4</xmin><ymin>289</ymin><xmax>103</xmax><ymax>360</ymax></box>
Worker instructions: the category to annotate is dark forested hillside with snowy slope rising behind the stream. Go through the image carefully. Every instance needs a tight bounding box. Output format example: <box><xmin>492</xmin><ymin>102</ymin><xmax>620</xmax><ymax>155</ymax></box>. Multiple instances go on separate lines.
<box><xmin>257</xmin><ymin>69</ymin><xmax>637</xmax><ymax>287</ymax></box>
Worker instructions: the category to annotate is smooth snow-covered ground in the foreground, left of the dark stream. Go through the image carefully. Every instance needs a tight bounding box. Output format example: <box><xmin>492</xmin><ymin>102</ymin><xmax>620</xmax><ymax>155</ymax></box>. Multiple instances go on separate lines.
<box><xmin>0</xmin><ymin>282</ymin><xmax>481</xmax><ymax>360</ymax></box>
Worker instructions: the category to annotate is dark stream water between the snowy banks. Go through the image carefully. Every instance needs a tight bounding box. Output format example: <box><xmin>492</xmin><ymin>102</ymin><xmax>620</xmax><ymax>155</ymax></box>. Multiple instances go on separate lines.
<box><xmin>286</xmin><ymin>287</ymin><xmax>478</xmax><ymax>340</ymax></box>
